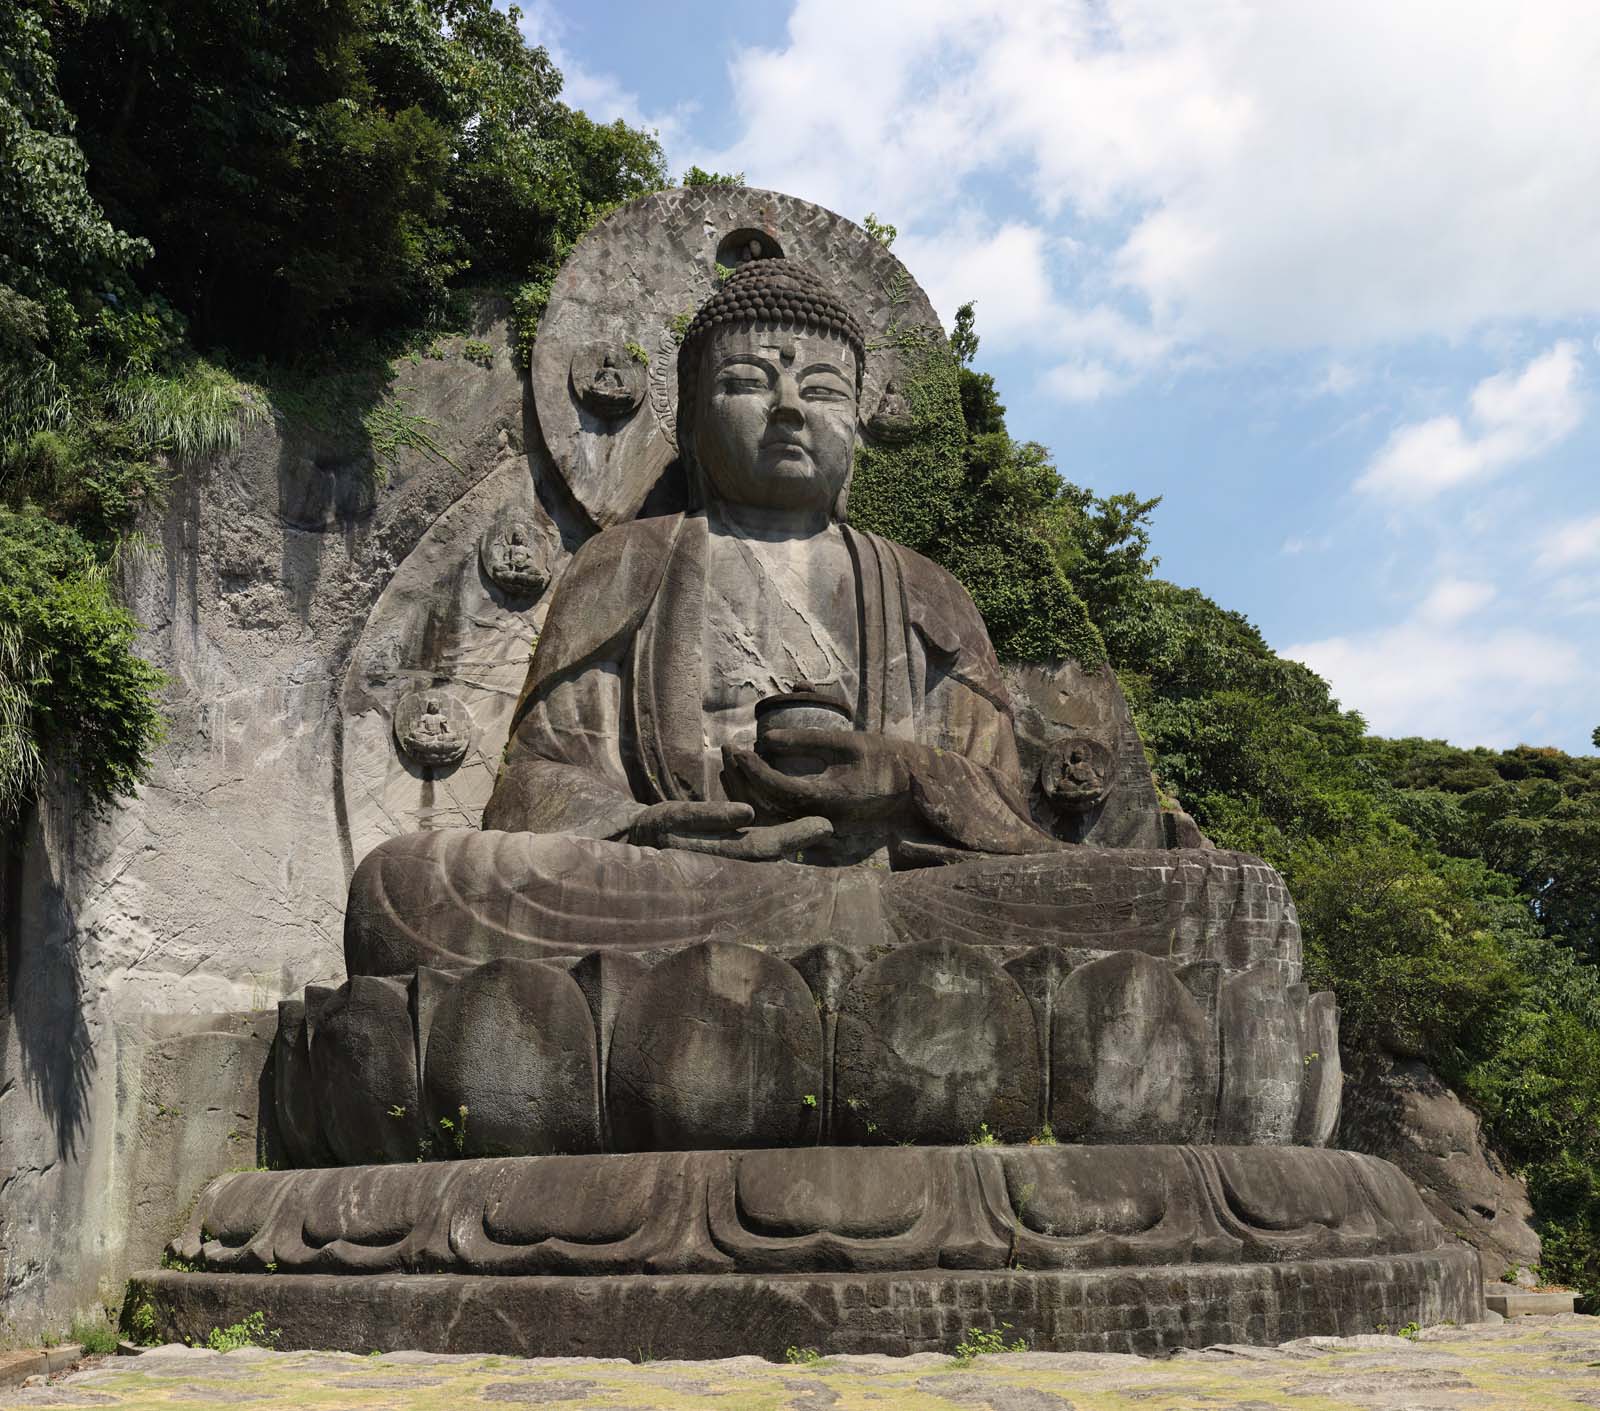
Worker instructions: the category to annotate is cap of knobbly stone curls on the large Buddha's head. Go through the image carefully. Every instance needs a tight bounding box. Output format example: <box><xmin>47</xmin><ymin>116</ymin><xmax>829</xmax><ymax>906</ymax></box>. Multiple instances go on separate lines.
<box><xmin>678</xmin><ymin>258</ymin><xmax>867</xmax><ymax>470</ymax></box>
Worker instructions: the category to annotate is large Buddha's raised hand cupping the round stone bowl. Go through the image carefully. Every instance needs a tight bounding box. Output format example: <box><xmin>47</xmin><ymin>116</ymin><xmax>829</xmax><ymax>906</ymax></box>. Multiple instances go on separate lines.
<box><xmin>722</xmin><ymin>729</ymin><xmax>922</xmax><ymax>819</ymax></box>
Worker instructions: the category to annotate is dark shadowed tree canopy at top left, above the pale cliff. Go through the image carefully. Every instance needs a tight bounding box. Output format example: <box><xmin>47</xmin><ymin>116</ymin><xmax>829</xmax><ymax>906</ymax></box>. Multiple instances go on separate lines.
<box><xmin>53</xmin><ymin>0</ymin><xmax>666</xmax><ymax>352</ymax></box>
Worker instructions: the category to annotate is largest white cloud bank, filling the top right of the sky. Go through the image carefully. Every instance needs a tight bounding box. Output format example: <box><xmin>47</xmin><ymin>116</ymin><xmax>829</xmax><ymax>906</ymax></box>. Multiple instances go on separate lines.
<box><xmin>696</xmin><ymin>0</ymin><xmax>1600</xmax><ymax>346</ymax></box>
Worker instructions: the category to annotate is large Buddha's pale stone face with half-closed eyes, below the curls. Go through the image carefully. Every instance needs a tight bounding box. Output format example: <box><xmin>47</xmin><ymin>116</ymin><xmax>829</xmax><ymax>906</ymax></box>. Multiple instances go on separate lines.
<box><xmin>694</xmin><ymin>325</ymin><xmax>856</xmax><ymax>514</ymax></box>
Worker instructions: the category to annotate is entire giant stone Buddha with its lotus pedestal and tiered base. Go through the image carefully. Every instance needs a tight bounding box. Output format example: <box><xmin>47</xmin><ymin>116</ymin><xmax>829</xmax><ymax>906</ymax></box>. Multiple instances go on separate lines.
<box><xmin>159</xmin><ymin>233</ymin><xmax>1480</xmax><ymax>1357</ymax></box>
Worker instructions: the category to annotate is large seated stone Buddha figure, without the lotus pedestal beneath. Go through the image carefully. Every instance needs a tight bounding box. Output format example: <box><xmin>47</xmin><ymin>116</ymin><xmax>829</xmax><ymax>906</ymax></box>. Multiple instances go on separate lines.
<box><xmin>346</xmin><ymin>259</ymin><xmax>1298</xmax><ymax>974</ymax></box>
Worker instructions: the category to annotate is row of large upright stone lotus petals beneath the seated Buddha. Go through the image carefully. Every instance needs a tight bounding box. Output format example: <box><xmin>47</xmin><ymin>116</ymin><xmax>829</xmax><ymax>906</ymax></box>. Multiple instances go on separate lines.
<box><xmin>284</xmin><ymin>934</ymin><xmax>1339</xmax><ymax>1166</ymax></box>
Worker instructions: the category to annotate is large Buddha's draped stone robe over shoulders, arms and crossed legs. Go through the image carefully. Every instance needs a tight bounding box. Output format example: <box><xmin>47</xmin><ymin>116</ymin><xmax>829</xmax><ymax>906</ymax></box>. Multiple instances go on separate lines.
<box><xmin>346</xmin><ymin>514</ymin><xmax>1299</xmax><ymax>974</ymax></box>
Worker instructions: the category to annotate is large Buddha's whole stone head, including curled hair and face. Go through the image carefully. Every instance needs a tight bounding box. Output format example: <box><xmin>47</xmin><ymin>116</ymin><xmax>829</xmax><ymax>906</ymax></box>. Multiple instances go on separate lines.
<box><xmin>678</xmin><ymin>259</ymin><xmax>866</xmax><ymax>518</ymax></box>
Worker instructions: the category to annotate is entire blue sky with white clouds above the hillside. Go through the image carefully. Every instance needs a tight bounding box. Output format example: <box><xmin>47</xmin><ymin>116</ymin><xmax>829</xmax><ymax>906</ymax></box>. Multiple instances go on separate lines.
<box><xmin>523</xmin><ymin>0</ymin><xmax>1600</xmax><ymax>753</ymax></box>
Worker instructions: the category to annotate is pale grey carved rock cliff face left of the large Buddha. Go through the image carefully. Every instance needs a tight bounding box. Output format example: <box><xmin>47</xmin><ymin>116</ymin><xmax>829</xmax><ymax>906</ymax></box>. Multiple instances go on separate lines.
<box><xmin>0</xmin><ymin>307</ymin><xmax>544</xmax><ymax>1339</ymax></box>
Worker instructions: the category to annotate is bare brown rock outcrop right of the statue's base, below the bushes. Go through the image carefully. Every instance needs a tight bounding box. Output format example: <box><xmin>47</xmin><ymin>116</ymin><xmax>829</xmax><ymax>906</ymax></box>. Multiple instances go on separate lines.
<box><xmin>1336</xmin><ymin>1056</ymin><xmax>1539</xmax><ymax>1280</ymax></box>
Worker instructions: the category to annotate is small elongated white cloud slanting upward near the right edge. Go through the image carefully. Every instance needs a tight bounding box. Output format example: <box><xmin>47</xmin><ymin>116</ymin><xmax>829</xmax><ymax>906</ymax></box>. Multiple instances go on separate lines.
<box><xmin>1355</xmin><ymin>339</ymin><xmax>1582</xmax><ymax>501</ymax></box>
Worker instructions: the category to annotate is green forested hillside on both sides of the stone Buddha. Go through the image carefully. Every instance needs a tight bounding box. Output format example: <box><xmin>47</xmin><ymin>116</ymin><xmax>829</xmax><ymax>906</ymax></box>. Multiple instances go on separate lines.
<box><xmin>0</xmin><ymin>0</ymin><xmax>1600</xmax><ymax>1296</ymax></box>
